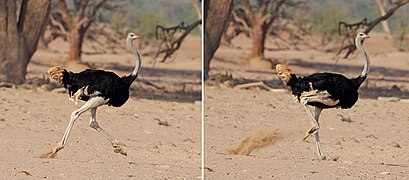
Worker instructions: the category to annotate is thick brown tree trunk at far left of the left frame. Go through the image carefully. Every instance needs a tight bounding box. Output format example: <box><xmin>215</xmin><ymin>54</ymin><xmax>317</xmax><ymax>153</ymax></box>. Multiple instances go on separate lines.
<box><xmin>0</xmin><ymin>0</ymin><xmax>51</xmax><ymax>84</ymax></box>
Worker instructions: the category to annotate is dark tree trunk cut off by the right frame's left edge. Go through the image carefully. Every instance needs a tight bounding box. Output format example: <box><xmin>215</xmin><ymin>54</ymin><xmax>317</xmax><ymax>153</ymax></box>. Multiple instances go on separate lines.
<box><xmin>204</xmin><ymin>0</ymin><xmax>233</xmax><ymax>80</ymax></box>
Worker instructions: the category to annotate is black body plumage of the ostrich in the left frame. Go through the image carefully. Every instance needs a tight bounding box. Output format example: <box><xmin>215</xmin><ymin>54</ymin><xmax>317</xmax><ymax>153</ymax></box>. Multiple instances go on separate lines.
<box><xmin>62</xmin><ymin>69</ymin><xmax>137</xmax><ymax>107</ymax></box>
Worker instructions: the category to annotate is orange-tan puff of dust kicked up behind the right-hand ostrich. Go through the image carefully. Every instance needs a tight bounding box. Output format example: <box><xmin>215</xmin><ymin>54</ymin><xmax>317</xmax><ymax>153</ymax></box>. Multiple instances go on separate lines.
<box><xmin>229</xmin><ymin>129</ymin><xmax>278</xmax><ymax>156</ymax></box>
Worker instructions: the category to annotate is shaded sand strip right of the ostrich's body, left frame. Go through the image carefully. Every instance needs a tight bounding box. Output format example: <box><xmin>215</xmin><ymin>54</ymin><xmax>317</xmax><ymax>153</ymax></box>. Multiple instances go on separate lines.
<box><xmin>105</xmin><ymin>64</ymin><xmax>202</xmax><ymax>103</ymax></box>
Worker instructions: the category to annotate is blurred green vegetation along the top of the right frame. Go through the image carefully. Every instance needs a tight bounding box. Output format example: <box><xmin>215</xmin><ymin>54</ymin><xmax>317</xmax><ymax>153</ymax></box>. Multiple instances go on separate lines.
<box><xmin>306</xmin><ymin>0</ymin><xmax>409</xmax><ymax>51</ymax></box>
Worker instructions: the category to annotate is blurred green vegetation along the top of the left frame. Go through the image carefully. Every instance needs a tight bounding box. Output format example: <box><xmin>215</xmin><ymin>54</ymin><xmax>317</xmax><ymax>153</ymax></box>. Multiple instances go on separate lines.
<box><xmin>101</xmin><ymin>0</ymin><xmax>200</xmax><ymax>43</ymax></box>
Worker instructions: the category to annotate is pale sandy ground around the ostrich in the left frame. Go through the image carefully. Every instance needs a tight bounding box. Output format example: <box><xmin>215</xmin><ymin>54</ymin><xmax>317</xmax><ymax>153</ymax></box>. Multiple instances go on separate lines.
<box><xmin>0</xmin><ymin>35</ymin><xmax>201</xmax><ymax>179</ymax></box>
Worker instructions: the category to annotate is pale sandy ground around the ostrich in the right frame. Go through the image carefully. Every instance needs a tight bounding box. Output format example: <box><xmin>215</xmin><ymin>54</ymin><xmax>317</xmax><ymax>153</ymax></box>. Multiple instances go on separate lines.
<box><xmin>204</xmin><ymin>34</ymin><xmax>409</xmax><ymax>179</ymax></box>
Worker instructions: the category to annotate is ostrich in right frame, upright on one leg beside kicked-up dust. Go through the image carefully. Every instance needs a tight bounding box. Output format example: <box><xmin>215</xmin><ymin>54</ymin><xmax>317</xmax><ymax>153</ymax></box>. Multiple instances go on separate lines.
<box><xmin>276</xmin><ymin>33</ymin><xmax>369</xmax><ymax>160</ymax></box>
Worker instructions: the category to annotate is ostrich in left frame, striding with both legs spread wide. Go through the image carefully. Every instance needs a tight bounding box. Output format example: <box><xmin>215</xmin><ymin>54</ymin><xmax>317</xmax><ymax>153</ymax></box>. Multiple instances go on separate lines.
<box><xmin>41</xmin><ymin>33</ymin><xmax>141</xmax><ymax>158</ymax></box>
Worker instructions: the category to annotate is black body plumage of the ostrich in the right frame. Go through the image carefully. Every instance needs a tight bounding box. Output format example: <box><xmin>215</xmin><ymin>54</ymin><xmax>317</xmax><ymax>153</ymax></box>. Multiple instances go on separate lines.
<box><xmin>287</xmin><ymin>73</ymin><xmax>366</xmax><ymax>109</ymax></box>
